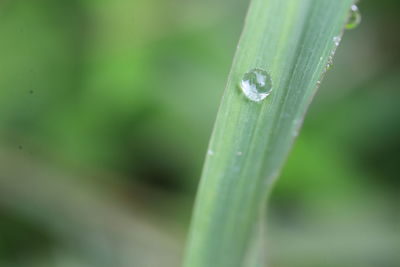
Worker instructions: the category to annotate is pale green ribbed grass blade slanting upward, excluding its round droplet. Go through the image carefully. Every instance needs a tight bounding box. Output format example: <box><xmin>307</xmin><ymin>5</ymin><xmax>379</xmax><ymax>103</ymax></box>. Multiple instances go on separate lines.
<box><xmin>184</xmin><ymin>0</ymin><xmax>353</xmax><ymax>267</ymax></box>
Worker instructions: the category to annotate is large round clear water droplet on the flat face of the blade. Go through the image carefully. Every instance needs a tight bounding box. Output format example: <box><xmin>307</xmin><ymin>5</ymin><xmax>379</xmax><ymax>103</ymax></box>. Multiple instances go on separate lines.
<box><xmin>240</xmin><ymin>69</ymin><xmax>272</xmax><ymax>102</ymax></box>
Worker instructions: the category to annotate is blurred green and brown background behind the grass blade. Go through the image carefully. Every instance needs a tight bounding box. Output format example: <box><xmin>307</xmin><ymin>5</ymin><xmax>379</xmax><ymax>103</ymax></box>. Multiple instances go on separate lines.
<box><xmin>0</xmin><ymin>0</ymin><xmax>400</xmax><ymax>267</ymax></box>
